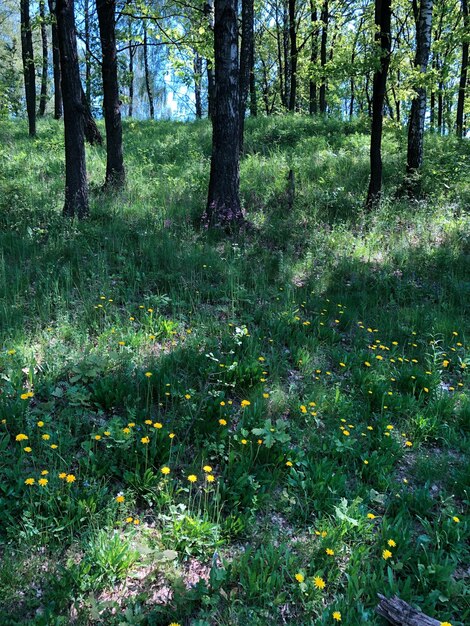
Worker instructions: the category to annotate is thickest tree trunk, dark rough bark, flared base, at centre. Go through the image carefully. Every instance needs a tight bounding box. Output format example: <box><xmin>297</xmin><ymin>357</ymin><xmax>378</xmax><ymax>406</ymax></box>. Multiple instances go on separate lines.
<box><xmin>202</xmin><ymin>0</ymin><xmax>244</xmax><ymax>230</ymax></box>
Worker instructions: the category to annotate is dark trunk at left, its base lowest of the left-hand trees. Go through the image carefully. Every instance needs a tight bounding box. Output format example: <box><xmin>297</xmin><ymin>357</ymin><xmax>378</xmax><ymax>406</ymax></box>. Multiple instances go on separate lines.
<box><xmin>56</xmin><ymin>0</ymin><xmax>88</xmax><ymax>218</ymax></box>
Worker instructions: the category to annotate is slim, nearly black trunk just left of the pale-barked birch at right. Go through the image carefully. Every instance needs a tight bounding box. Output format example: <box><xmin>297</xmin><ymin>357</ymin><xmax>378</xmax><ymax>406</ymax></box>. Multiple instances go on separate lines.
<box><xmin>366</xmin><ymin>0</ymin><xmax>392</xmax><ymax>209</ymax></box>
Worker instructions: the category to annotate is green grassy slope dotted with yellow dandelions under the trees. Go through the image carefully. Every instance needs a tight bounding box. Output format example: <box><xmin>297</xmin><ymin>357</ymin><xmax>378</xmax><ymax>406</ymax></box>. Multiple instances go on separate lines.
<box><xmin>0</xmin><ymin>116</ymin><xmax>470</xmax><ymax>626</ymax></box>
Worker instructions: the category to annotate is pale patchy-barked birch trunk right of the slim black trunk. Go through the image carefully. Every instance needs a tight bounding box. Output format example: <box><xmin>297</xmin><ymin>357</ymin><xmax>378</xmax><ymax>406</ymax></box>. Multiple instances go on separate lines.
<box><xmin>406</xmin><ymin>0</ymin><xmax>433</xmax><ymax>188</ymax></box>
